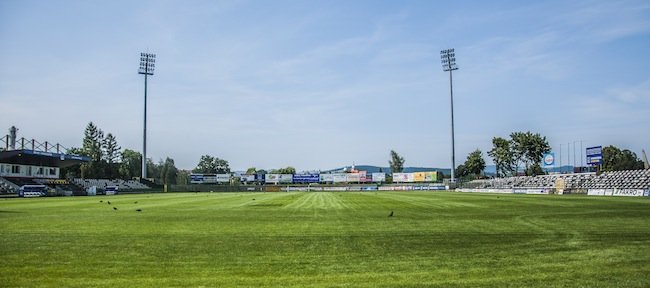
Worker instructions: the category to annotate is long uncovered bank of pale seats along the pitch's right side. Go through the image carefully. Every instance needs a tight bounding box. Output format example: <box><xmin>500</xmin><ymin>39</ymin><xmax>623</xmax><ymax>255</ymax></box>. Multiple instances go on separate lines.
<box><xmin>462</xmin><ymin>169</ymin><xmax>650</xmax><ymax>190</ymax></box>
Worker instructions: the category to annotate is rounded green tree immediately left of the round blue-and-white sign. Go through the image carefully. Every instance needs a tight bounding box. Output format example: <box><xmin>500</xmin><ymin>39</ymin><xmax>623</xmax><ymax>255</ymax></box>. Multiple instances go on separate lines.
<box><xmin>510</xmin><ymin>132</ymin><xmax>551</xmax><ymax>173</ymax></box>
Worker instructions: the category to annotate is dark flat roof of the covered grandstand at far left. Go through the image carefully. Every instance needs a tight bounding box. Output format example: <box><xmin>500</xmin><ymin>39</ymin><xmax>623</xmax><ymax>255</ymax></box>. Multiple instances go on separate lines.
<box><xmin>0</xmin><ymin>149</ymin><xmax>90</xmax><ymax>168</ymax></box>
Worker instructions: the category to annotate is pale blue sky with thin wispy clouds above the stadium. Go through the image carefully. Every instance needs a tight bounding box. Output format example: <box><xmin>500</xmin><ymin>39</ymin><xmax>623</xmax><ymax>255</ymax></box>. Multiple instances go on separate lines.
<box><xmin>0</xmin><ymin>0</ymin><xmax>650</xmax><ymax>170</ymax></box>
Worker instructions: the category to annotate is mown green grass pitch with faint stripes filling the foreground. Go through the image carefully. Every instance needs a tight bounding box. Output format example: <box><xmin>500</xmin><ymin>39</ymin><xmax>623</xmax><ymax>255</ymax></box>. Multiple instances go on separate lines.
<box><xmin>0</xmin><ymin>192</ymin><xmax>650</xmax><ymax>287</ymax></box>
